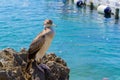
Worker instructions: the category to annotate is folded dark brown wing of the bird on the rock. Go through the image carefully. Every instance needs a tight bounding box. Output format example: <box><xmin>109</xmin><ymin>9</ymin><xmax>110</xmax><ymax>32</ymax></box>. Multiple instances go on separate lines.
<box><xmin>28</xmin><ymin>33</ymin><xmax>45</xmax><ymax>59</ymax></box>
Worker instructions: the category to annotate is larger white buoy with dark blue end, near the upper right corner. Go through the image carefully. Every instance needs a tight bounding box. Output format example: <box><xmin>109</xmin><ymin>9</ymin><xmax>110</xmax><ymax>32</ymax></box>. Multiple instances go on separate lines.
<box><xmin>97</xmin><ymin>5</ymin><xmax>112</xmax><ymax>18</ymax></box>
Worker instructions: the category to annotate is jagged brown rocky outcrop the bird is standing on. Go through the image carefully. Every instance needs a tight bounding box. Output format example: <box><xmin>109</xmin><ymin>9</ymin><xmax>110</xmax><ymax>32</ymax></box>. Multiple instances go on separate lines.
<box><xmin>0</xmin><ymin>48</ymin><xmax>70</xmax><ymax>80</ymax></box>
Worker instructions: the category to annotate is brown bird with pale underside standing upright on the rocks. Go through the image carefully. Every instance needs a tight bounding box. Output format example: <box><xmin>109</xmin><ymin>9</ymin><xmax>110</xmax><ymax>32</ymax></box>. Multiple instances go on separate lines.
<box><xmin>26</xmin><ymin>19</ymin><xmax>55</xmax><ymax>71</ymax></box>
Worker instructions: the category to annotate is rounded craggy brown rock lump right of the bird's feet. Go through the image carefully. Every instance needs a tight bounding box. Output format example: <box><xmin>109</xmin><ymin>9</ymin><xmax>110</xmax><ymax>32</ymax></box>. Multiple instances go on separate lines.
<box><xmin>43</xmin><ymin>53</ymin><xmax>70</xmax><ymax>80</ymax></box>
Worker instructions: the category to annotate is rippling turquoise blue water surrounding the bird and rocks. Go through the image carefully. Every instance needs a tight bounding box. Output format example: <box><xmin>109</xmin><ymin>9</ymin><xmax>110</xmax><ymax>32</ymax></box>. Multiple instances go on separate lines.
<box><xmin>0</xmin><ymin>0</ymin><xmax>120</xmax><ymax>80</ymax></box>
